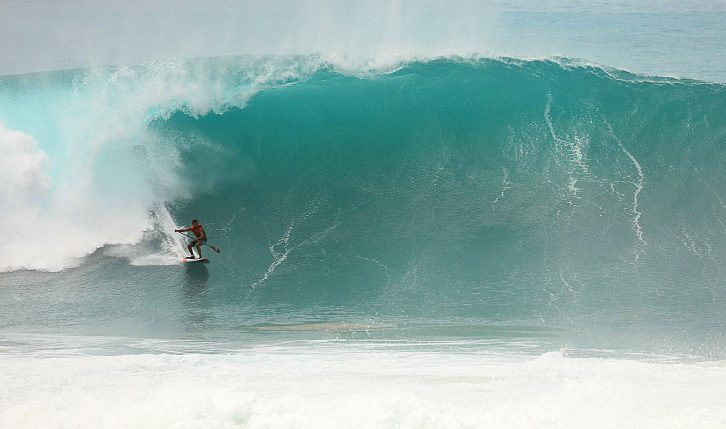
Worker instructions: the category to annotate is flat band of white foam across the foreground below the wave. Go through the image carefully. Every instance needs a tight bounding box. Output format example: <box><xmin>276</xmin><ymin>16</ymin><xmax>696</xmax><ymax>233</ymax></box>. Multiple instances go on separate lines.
<box><xmin>0</xmin><ymin>346</ymin><xmax>726</xmax><ymax>429</ymax></box>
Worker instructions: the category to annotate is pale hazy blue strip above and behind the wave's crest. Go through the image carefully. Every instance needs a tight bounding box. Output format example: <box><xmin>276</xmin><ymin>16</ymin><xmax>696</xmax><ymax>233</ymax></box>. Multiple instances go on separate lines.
<box><xmin>0</xmin><ymin>0</ymin><xmax>726</xmax><ymax>81</ymax></box>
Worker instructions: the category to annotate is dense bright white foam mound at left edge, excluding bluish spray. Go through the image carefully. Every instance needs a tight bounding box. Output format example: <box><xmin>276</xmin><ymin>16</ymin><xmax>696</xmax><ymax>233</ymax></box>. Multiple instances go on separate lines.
<box><xmin>0</xmin><ymin>125</ymin><xmax>147</xmax><ymax>271</ymax></box>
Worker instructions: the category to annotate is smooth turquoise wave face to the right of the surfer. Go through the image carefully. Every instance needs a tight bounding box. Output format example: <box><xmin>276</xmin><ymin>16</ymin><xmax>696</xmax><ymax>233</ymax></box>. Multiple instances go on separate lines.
<box><xmin>156</xmin><ymin>60</ymin><xmax>726</xmax><ymax>320</ymax></box>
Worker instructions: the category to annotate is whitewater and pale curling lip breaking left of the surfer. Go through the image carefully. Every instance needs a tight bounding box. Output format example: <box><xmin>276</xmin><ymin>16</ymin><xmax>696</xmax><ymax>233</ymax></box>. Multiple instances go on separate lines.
<box><xmin>0</xmin><ymin>57</ymin><xmax>323</xmax><ymax>271</ymax></box>
